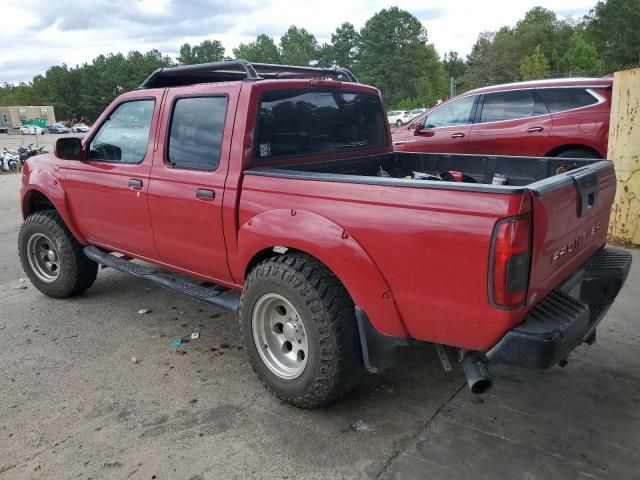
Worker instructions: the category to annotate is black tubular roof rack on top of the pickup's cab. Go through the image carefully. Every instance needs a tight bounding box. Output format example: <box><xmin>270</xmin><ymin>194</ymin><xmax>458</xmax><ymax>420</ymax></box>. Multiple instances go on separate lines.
<box><xmin>138</xmin><ymin>59</ymin><xmax>358</xmax><ymax>89</ymax></box>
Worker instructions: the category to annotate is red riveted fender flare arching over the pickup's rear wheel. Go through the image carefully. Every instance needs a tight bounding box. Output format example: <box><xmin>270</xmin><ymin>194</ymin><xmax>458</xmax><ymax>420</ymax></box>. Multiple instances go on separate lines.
<box><xmin>234</xmin><ymin>209</ymin><xmax>408</xmax><ymax>337</ymax></box>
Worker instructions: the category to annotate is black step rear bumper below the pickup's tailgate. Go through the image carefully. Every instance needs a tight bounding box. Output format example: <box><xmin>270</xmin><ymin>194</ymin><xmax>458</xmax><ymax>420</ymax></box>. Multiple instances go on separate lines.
<box><xmin>486</xmin><ymin>248</ymin><xmax>631</xmax><ymax>369</ymax></box>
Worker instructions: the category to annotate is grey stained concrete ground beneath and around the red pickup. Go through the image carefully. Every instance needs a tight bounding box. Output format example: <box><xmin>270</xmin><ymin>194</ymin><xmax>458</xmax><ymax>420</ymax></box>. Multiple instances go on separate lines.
<box><xmin>0</xmin><ymin>163</ymin><xmax>640</xmax><ymax>480</ymax></box>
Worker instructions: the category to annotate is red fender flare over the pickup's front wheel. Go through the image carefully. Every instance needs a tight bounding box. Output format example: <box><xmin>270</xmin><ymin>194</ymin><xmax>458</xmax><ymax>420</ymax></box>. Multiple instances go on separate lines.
<box><xmin>21</xmin><ymin>170</ymin><xmax>87</xmax><ymax>245</ymax></box>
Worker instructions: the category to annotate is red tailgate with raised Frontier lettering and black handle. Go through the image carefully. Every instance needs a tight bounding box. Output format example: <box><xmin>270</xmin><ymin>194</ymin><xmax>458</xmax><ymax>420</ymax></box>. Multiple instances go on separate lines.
<box><xmin>527</xmin><ymin>160</ymin><xmax>616</xmax><ymax>306</ymax></box>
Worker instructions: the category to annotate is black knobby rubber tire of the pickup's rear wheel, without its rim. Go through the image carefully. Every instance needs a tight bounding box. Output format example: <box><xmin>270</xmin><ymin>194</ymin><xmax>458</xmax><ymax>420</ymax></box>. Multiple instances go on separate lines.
<box><xmin>240</xmin><ymin>253</ymin><xmax>364</xmax><ymax>408</ymax></box>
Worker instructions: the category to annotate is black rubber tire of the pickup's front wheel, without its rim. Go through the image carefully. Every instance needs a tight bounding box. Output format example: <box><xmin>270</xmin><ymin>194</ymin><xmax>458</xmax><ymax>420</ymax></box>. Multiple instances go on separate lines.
<box><xmin>18</xmin><ymin>210</ymin><xmax>98</xmax><ymax>298</ymax></box>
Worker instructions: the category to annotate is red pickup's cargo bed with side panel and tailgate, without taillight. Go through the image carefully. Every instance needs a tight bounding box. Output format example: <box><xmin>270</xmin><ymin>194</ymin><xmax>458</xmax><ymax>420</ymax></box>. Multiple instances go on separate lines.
<box><xmin>239</xmin><ymin>152</ymin><xmax>615</xmax><ymax>351</ymax></box>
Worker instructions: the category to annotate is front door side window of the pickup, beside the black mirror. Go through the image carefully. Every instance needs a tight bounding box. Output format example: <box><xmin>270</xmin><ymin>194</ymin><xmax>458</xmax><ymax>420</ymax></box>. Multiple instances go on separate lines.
<box><xmin>89</xmin><ymin>100</ymin><xmax>154</xmax><ymax>163</ymax></box>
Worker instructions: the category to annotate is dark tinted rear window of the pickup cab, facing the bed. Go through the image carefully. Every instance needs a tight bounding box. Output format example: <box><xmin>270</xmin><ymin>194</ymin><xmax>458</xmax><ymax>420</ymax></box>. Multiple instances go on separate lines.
<box><xmin>256</xmin><ymin>90</ymin><xmax>388</xmax><ymax>158</ymax></box>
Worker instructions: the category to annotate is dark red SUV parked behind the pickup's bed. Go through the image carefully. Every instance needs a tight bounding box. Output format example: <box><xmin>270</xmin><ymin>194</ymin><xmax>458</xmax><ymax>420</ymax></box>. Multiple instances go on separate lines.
<box><xmin>392</xmin><ymin>78</ymin><xmax>613</xmax><ymax>158</ymax></box>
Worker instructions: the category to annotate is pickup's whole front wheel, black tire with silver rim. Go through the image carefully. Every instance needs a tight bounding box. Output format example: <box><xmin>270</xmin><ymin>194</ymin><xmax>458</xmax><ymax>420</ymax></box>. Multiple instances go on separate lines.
<box><xmin>18</xmin><ymin>210</ymin><xmax>98</xmax><ymax>298</ymax></box>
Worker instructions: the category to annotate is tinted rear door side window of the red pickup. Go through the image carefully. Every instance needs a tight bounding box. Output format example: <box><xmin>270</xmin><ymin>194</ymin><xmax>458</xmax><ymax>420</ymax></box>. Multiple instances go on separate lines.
<box><xmin>167</xmin><ymin>97</ymin><xmax>227</xmax><ymax>170</ymax></box>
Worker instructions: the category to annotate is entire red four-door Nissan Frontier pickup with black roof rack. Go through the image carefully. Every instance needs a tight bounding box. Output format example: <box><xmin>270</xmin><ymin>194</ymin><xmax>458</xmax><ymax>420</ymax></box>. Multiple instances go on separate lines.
<box><xmin>19</xmin><ymin>60</ymin><xmax>631</xmax><ymax>407</ymax></box>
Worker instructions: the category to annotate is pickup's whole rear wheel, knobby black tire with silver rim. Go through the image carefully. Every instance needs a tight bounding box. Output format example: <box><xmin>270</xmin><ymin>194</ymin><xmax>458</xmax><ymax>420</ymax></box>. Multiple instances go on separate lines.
<box><xmin>240</xmin><ymin>254</ymin><xmax>363</xmax><ymax>408</ymax></box>
